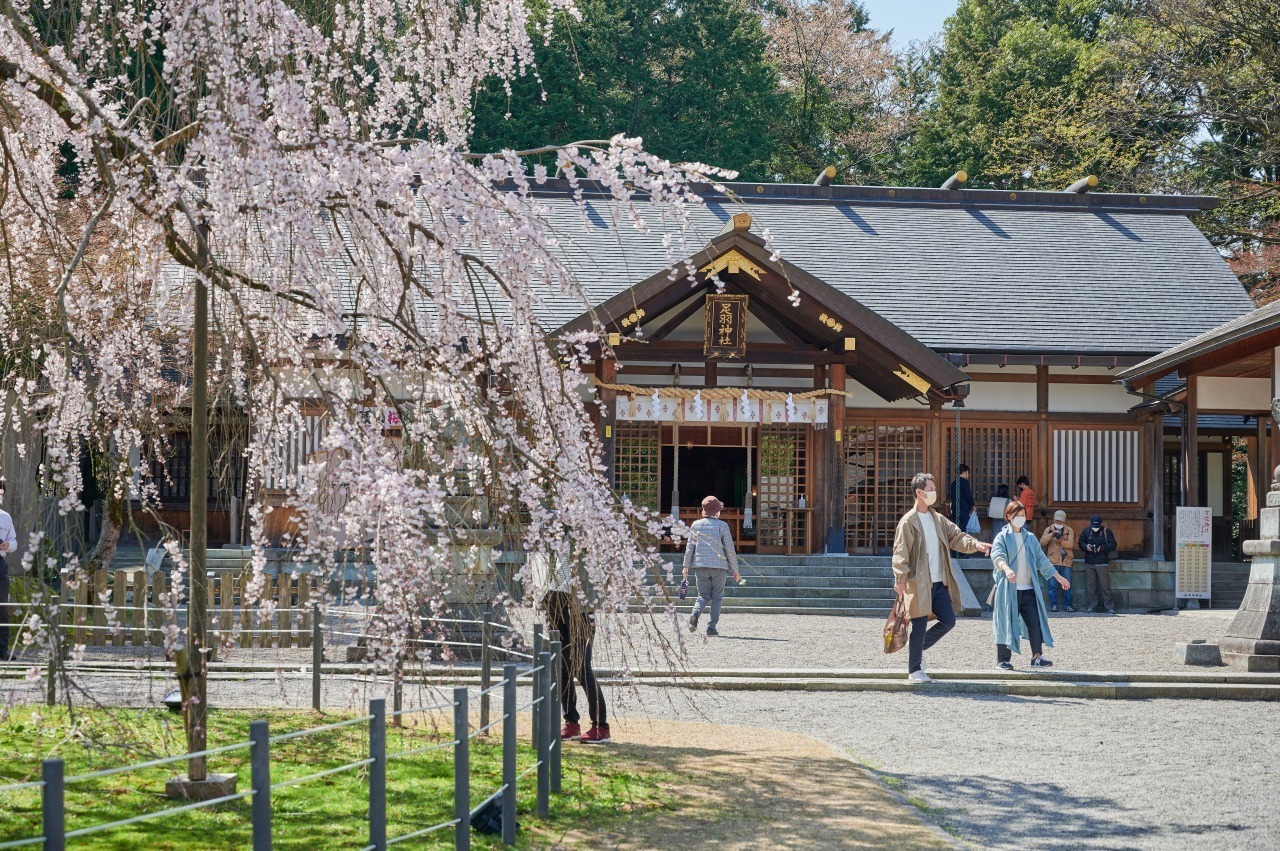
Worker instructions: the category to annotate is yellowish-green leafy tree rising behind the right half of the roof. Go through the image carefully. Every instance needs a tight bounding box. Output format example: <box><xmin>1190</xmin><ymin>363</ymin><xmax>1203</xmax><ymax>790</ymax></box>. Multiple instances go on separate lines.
<box><xmin>902</xmin><ymin>0</ymin><xmax>1189</xmax><ymax>192</ymax></box>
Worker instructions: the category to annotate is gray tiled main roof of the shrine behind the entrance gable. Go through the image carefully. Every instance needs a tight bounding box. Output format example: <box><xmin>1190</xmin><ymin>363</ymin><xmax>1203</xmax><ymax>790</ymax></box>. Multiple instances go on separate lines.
<box><xmin>524</xmin><ymin>184</ymin><xmax>1252</xmax><ymax>354</ymax></box>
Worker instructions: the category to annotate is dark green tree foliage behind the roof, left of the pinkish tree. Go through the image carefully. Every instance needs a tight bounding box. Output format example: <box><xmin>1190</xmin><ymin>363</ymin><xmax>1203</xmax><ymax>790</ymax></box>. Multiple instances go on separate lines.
<box><xmin>472</xmin><ymin>0</ymin><xmax>781</xmax><ymax>179</ymax></box>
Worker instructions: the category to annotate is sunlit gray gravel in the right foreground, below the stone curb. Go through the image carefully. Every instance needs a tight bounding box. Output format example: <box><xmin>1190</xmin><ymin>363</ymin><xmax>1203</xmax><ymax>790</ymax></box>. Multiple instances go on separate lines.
<box><xmin>629</xmin><ymin>686</ymin><xmax>1280</xmax><ymax>848</ymax></box>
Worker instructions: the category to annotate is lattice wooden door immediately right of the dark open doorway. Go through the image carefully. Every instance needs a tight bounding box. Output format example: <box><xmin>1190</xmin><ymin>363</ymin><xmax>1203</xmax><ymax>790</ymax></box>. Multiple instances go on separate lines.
<box><xmin>756</xmin><ymin>425</ymin><xmax>813</xmax><ymax>553</ymax></box>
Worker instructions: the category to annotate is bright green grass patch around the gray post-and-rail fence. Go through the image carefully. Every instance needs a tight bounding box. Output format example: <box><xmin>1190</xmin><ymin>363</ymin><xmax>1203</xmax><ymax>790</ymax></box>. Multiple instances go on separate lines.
<box><xmin>0</xmin><ymin>708</ymin><xmax>672</xmax><ymax>851</ymax></box>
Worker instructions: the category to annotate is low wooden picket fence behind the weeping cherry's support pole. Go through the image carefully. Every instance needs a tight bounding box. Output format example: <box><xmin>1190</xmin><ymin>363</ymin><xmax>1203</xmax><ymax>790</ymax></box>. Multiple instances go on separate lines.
<box><xmin>61</xmin><ymin>569</ymin><xmax>316</xmax><ymax>648</ymax></box>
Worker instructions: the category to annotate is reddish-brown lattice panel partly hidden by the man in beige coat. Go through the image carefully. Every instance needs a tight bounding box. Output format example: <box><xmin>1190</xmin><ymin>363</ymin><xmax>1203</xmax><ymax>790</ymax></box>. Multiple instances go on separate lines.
<box><xmin>844</xmin><ymin>422</ymin><xmax>924</xmax><ymax>553</ymax></box>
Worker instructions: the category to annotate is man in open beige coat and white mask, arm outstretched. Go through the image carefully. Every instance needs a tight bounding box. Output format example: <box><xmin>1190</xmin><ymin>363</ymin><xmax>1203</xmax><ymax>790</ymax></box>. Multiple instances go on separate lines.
<box><xmin>893</xmin><ymin>472</ymin><xmax>991</xmax><ymax>682</ymax></box>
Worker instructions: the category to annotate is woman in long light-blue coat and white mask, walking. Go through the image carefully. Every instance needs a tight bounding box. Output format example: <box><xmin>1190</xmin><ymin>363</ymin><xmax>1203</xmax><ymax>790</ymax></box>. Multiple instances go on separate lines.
<box><xmin>991</xmin><ymin>500</ymin><xmax>1071</xmax><ymax>671</ymax></box>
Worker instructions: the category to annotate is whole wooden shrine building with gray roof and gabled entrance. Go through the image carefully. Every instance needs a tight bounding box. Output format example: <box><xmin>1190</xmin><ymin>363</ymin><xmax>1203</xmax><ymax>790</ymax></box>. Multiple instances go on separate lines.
<box><xmin>535</xmin><ymin>180</ymin><xmax>1259</xmax><ymax>561</ymax></box>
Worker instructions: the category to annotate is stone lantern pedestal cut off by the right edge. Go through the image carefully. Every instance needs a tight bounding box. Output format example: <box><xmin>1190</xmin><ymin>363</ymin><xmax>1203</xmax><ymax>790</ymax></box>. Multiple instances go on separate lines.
<box><xmin>1219</xmin><ymin>467</ymin><xmax>1280</xmax><ymax>673</ymax></box>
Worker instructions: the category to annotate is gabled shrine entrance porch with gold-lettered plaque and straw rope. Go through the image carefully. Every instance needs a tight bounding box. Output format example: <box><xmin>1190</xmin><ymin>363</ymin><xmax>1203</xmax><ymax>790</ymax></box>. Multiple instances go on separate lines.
<box><xmin>558</xmin><ymin>212</ymin><xmax>968</xmax><ymax>555</ymax></box>
